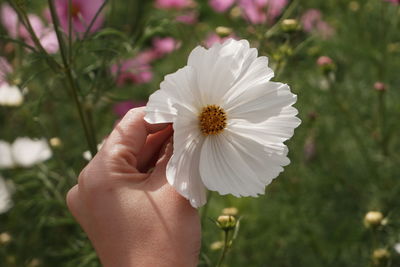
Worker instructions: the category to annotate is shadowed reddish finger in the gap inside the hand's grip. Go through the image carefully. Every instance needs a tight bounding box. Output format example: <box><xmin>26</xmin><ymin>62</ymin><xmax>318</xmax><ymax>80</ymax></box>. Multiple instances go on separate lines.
<box><xmin>137</xmin><ymin>126</ymin><xmax>173</xmax><ymax>173</ymax></box>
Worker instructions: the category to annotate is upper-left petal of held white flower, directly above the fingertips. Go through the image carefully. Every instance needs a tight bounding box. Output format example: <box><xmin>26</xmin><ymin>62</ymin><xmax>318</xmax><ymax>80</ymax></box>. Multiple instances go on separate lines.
<box><xmin>145</xmin><ymin>67</ymin><xmax>199</xmax><ymax>123</ymax></box>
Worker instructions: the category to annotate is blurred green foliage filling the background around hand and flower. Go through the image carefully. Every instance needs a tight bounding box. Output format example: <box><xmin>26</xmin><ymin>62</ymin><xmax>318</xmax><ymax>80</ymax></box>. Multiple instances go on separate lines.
<box><xmin>0</xmin><ymin>0</ymin><xmax>400</xmax><ymax>267</ymax></box>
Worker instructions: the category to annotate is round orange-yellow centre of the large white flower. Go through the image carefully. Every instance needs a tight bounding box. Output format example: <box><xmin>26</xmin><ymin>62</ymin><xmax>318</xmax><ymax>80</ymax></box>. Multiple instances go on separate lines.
<box><xmin>199</xmin><ymin>105</ymin><xmax>227</xmax><ymax>135</ymax></box>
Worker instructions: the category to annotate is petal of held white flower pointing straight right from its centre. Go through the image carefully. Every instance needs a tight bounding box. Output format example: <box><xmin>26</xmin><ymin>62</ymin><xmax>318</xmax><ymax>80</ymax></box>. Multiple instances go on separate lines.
<box><xmin>228</xmin><ymin>106</ymin><xmax>301</xmax><ymax>146</ymax></box>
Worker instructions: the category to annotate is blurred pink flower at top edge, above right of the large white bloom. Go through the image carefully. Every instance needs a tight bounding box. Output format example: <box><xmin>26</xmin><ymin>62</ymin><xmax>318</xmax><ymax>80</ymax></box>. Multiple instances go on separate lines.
<box><xmin>239</xmin><ymin>0</ymin><xmax>288</xmax><ymax>24</ymax></box>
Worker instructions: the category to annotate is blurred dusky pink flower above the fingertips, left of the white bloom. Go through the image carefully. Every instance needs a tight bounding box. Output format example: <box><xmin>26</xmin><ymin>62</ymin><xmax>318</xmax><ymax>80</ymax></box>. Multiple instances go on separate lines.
<box><xmin>111</xmin><ymin>58</ymin><xmax>153</xmax><ymax>86</ymax></box>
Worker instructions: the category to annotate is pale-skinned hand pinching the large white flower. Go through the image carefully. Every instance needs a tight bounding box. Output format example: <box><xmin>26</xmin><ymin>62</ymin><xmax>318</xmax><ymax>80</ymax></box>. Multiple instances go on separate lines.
<box><xmin>67</xmin><ymin>108</ymin><xmax>201</xmax><ymax>267</ymax></box>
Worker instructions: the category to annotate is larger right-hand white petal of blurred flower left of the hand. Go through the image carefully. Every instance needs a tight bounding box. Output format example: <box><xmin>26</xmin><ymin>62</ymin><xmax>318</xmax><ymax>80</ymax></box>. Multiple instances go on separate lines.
<box><xmin>11</xmin><ymin>137</ymin><xmax>52</xmax><ymax>167</ymax></box>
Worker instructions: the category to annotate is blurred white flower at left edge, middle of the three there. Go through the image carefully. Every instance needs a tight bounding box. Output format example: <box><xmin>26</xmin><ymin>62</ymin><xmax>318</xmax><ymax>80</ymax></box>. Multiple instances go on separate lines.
<box><xmin>0</xmin><ymin>137</ymin><xmax>52</xmax><ymax>168</ymax></box>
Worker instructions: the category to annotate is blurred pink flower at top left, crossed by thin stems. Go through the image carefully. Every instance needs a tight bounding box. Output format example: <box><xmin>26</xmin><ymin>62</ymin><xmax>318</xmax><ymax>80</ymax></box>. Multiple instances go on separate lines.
<box><xmin>55</xmin><ymin>0</ymin><xmax>104</xmax><ymax>33</ymax></box>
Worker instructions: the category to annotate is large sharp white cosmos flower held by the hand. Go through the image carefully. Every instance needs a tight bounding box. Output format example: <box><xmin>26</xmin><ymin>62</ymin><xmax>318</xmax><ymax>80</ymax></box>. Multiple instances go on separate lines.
<box><xmin>145</xmin><ymin>39</ymin><xmax>300</xmax><ymax>207</ymax></box>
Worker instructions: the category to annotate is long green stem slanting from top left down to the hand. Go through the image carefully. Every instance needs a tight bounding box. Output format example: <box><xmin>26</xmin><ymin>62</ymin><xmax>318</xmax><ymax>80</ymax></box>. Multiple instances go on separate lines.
<box><xmin>48</xmin><ymin>0</ymin><xmax>97</xmax><ymax>156</ymax></box>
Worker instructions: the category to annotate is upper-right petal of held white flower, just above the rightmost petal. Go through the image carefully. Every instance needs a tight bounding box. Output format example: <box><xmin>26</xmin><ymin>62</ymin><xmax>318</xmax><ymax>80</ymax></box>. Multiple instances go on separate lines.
<box><xmin>226</xmin><ymin>82</ymin><xmax>297</xmax><ymax>123</ymax></box>
